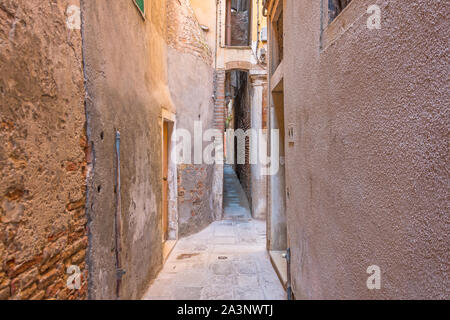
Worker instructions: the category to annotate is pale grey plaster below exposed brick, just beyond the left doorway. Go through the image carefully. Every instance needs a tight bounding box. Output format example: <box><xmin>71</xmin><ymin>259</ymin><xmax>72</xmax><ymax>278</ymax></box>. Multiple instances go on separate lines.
<box><xmin>168</xmin><ymin>48</ymin><xmax>214</xmax><ymax>237</ymax></box>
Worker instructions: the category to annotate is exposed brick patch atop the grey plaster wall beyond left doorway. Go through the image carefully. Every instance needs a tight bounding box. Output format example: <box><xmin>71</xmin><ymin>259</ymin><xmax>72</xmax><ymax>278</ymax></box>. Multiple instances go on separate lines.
<box><xmin>167</xmin><ymin>0</ymin><xmax>212</xmax><ymax>64</ymax></box>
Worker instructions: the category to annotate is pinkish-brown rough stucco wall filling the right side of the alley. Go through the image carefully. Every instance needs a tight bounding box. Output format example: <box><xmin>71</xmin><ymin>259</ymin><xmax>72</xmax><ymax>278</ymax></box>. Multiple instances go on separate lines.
<box><xmin>283</xmin><ymin>0</ymin><xmax>450</xmax><ymax>299</ymax></box>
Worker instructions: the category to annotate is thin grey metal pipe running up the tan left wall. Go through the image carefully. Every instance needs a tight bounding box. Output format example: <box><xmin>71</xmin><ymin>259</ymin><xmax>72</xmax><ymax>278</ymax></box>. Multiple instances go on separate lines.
<box><xmin>114</xmin><ymin>131</ymin><xmax>125</xmax><ymax>299</ymax></box>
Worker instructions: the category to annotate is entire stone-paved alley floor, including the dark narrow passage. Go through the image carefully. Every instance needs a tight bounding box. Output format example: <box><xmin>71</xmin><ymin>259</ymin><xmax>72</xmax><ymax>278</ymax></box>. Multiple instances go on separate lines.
<box><xmin>143</xmin><ymin>167</ymin><xmax>286</xmax><ymax>300</ymax></box>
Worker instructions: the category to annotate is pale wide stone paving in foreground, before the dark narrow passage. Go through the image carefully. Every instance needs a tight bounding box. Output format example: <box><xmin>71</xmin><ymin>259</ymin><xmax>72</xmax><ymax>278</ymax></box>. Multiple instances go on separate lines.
<box><xmin>143</xmin><ymin>220</ymin><xmax>286</xmax><ymax>300</ymax></box>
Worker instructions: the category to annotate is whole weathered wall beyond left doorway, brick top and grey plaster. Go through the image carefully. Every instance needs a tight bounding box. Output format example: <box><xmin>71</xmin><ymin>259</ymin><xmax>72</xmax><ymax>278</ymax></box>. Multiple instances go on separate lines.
<box><xmin>167</xmin><ymin>0</ymin><xmax>214</xmax><ymax>237</ymax></box>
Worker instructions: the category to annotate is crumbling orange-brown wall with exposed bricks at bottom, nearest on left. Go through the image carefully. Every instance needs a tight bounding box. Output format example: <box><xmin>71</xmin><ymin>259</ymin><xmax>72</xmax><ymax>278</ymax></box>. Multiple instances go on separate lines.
<box><xmin>0</xmin><ymin>0</ymin><xmax>87</xmax><ymax>300</ymax></box>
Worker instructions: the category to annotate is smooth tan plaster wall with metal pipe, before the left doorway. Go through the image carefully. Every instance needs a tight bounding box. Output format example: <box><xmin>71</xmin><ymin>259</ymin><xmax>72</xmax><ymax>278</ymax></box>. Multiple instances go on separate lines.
<box><xmin>82</xmin><ymin>0</ymin><xmax>171</xmax><ymax>299</ymax></box>
